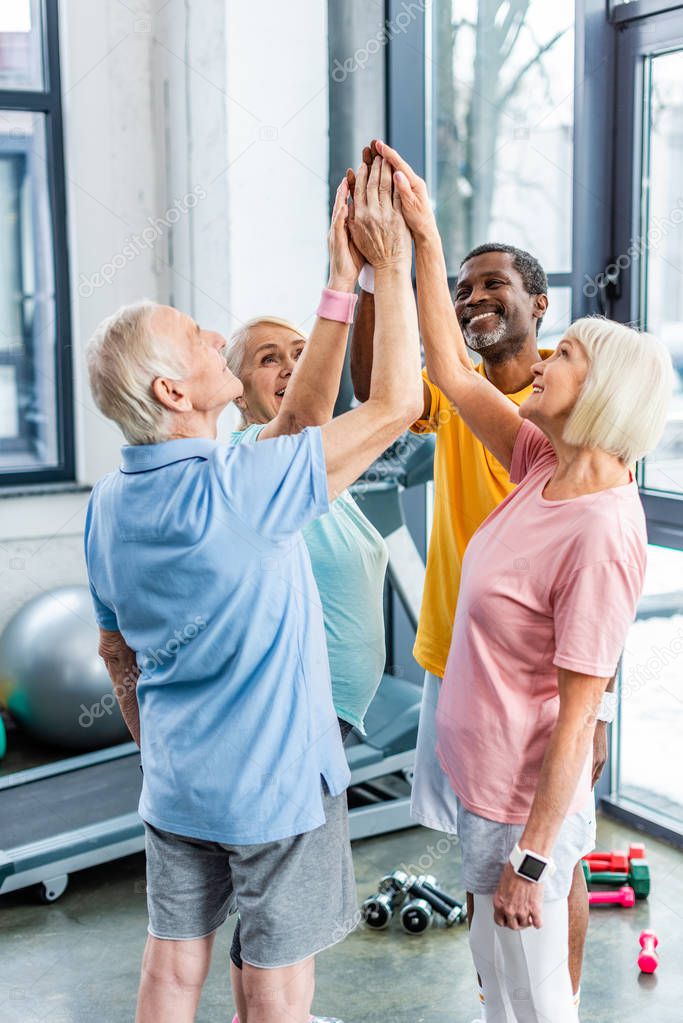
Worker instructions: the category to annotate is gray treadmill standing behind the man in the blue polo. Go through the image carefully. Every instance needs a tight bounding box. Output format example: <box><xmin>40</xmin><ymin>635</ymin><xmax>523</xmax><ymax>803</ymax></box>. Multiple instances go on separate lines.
<box><xmin>0</xmin><ymin>434</ymin><xmax>434</xmax><ymax>902</ymax></box>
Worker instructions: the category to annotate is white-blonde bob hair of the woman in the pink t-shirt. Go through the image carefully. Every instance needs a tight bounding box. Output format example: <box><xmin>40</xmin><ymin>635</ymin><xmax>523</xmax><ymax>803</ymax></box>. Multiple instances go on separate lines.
<box><xmin>563</xmin><ymin>316</ymin><xmax>674</xmax><ymax>464</ymax></box>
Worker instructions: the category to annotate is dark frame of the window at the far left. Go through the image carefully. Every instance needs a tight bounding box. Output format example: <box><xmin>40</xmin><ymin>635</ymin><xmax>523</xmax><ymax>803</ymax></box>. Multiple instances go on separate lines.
<box><xmin>0</xmin><ymin>0</ymin><xmax>76</xmax><ymax>486</ymax></box>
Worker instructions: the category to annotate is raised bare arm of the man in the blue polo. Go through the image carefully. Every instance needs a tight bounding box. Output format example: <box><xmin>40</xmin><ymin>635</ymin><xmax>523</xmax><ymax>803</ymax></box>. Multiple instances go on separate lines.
<box><xmin>323</xmin><ymin>160</ymin><xmax>422</xmax><ymax>497</ymax></box>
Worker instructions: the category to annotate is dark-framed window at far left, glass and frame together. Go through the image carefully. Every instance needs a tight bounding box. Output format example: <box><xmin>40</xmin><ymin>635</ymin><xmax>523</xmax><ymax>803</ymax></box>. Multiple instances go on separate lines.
<box><xmin>0</xmin><ymin>0</ymin><xmax>74</xmax><ymax>486</ymax></box>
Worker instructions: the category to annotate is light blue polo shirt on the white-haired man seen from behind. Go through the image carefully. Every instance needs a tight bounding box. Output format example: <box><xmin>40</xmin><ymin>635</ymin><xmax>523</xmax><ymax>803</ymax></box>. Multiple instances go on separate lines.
<box><xmin>85</xmin><ymin>429</ymin><xmax>349</xmax><ymax>845</ymax></box>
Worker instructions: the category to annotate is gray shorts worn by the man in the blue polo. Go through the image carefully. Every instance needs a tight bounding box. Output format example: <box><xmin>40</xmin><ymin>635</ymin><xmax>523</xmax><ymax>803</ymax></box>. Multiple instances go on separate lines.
<box><xmin>145</xmin><ymin>786</ymin><xmax>358</xmax><ymax>969</ymax></box>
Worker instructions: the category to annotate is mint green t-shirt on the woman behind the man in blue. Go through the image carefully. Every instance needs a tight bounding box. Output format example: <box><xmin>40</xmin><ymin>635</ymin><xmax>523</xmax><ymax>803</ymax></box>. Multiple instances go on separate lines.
<box><xmin>232</xmin><ymin>424</ymin><xmax>389</xmax><ymax>731</ymax></box>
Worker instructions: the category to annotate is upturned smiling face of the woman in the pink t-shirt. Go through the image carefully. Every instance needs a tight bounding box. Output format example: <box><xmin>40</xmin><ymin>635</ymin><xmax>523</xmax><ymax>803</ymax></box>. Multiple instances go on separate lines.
<box><xmin>519</xmin><ymin>338</ymin><xmax>590</xmax><ymax>436</ymax></box>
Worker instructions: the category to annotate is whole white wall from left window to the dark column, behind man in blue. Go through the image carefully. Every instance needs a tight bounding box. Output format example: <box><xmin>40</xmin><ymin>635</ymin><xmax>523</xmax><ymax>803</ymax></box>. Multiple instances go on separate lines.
<box><xmin>0</xmin><ymin>0</ymin><xmax>328</xmax><ymax>627</ymax></box>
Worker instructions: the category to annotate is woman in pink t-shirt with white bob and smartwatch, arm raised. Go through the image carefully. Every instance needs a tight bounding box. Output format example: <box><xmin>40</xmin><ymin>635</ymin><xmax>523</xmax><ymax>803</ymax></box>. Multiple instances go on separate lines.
<box><xmin>377</xmin><ymin>143</ymin><xmax>673</xmax><ymax>1023</ymax></box>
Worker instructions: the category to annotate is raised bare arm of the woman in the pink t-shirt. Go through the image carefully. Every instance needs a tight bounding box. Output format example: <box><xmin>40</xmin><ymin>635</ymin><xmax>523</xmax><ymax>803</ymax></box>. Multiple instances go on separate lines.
<box><xmin>377</xmin><ymin>142</ymin><xmax>521</xmax><ymax>470</ymax></box>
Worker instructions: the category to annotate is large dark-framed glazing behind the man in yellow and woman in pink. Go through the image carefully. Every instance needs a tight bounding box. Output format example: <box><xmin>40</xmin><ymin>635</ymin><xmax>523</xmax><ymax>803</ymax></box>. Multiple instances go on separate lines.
<box><xmin>388</xmin><ymin>0</ymin><xmax>683</xmax><ymax>841</ymax></box>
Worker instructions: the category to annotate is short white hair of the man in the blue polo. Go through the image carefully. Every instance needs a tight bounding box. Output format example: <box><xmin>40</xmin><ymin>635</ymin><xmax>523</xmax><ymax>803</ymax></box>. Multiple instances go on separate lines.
<box><xmin>86</xmin><ymin>300</ymin><xmax>188</xmax><ymax>444</ymax></box>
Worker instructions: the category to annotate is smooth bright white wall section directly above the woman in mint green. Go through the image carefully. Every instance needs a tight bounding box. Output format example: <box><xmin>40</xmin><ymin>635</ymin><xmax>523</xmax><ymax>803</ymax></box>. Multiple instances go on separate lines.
<box><xmin>226</xmin><ymin>0</ymin><xmax>329</xmax><ymax>329</ymax></box>
